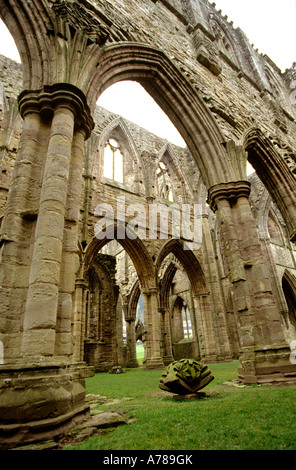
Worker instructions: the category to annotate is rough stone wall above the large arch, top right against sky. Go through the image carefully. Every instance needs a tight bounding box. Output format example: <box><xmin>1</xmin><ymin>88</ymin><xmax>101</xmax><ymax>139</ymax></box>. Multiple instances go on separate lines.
<box><xmin>80</xmin><ymin>0</ymin><xmax>295</xmax><ymax>159</ymax></box>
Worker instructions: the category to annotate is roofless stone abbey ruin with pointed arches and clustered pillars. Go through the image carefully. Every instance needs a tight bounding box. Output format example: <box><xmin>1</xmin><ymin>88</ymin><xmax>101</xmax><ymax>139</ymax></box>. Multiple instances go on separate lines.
<box><xmin>0</xmin><ymin>0</ymin><xmax>296</xmax><ymax>448</ymax></box>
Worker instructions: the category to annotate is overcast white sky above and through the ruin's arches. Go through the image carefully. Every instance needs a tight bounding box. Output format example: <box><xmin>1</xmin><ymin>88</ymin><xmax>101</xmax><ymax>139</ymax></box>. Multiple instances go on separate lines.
<box><xmin>0</xmin><ymin>0</ymin><xmax>296</xmax><ymax>145</ymax></box>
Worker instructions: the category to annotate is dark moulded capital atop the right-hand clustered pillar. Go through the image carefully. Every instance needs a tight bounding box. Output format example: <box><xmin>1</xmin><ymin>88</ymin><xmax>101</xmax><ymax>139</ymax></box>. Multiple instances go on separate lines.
<box><xmin>208</xmin><ymin>181</ymin><xmax>251</xmax><ymax>212</ymax></box>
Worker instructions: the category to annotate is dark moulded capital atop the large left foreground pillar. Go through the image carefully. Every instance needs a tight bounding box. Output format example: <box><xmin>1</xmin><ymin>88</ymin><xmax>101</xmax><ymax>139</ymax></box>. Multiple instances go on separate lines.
<box><xmin>18</xmin><ymin>83</ymin><xmax>94</xmax><ymax>139</ymax></box>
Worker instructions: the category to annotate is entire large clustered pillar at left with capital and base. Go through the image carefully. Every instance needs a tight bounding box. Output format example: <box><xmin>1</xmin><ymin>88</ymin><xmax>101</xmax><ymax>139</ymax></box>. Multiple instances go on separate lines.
<box><xmin>0</xmin><ymin>84</ymin><xmax>93</xmax><ymax>448</ymax></box>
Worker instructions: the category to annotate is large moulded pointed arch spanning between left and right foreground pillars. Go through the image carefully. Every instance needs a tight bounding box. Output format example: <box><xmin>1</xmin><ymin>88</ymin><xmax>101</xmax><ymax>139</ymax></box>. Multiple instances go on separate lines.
<box><xmin>86</xmin><ymin>43</ymin><xmax>238</xmax><ymax>189</ymax></box>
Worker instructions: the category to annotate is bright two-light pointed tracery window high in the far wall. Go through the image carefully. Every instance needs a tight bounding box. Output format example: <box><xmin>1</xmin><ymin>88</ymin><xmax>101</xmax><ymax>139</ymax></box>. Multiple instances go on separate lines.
<box><xmin>104</xmin><ymin>139</ymin><xmax>123</xmax><ymax>183</ymax></box>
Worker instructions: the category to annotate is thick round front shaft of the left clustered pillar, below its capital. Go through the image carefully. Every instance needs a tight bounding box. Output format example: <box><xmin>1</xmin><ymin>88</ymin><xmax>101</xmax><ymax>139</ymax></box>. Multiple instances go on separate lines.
<box><xmin>22</xmin><ymin>102</ymin><xmax>74</xmax><ymax>358</ymax></box>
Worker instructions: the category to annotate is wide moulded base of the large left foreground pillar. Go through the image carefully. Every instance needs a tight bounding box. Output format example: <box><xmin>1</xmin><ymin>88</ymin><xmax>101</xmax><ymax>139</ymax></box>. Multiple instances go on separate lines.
<box><xmin>0</xmin><ymin>363</ymin><xmax>93</xmax><ymax>449</ymax></box>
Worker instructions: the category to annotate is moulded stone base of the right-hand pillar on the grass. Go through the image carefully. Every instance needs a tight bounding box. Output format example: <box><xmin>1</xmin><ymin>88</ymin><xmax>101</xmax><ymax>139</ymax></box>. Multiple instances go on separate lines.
<box><xmin>238</xmin><ymin>345</ymin><xmax>296</xmax><ymax>385</ymax></box>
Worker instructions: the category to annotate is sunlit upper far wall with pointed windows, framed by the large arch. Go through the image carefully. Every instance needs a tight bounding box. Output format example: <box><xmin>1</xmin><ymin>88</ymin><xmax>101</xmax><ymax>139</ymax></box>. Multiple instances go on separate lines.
<box><xmin>84</xmin><ymin>103</ymin><xmax>200</xmax><ymax>242</ymax></box>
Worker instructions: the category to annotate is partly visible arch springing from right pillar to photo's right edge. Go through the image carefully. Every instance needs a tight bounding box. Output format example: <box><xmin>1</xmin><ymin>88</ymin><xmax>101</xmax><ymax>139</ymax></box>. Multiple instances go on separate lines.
<box><xmin>244</xmin><ymin>128</ymin><xmax>296</xmax><ymax>241</ymax></box>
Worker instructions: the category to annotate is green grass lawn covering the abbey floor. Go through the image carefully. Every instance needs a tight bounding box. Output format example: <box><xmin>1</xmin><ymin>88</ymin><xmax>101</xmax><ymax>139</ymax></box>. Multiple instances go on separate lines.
<box><xmin>67</xmin><ymin>362</ymin><xmax>296</xmax><ymax>450</ymax></box>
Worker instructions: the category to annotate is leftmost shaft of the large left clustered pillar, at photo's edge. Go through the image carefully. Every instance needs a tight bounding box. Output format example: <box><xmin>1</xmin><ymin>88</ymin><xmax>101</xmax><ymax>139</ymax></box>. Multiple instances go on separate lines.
<box><xmin>0</xmin><ymin>109</ymin><xmax>49</xmax><ymax>363</ymax></box>
